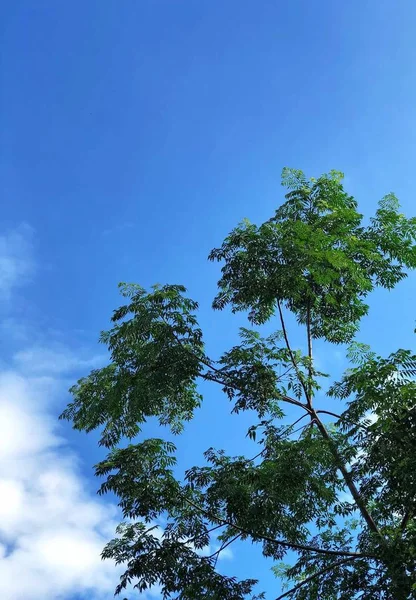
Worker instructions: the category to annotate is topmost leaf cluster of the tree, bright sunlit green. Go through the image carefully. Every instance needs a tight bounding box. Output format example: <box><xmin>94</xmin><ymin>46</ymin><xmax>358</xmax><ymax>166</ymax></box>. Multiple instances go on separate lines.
<box><xmin>210</xmin><ymin>169</ymin><xmax>416</xmax><ymax>343</ymax></box>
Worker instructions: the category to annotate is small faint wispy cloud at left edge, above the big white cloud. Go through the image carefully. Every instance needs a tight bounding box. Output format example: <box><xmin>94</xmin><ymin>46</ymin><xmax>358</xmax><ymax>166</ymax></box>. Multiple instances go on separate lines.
<box><xmin>0</xmin><ymin>224</ymin><xmax>35</xmax><ymax>300</ymax></box>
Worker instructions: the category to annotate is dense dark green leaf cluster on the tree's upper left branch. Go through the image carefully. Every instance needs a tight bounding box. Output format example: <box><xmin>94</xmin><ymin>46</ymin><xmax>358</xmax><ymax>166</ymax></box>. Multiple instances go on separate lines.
<box><xmin>62</xmin><ymin>285</ymin><xmax>203</xmax><ymax>447</ymax></box>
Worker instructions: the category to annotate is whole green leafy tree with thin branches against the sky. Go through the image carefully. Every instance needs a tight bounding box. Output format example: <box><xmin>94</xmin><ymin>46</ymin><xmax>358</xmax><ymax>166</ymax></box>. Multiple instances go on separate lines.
<box><xmin>62</xmin><ymin>169</ymin><xmax>416</xmax><ymax>600</ymax></box>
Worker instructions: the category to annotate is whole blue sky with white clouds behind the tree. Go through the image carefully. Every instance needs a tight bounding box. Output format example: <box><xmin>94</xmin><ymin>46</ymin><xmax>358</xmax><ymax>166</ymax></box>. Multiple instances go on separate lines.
<box><xmin>0</xmin><ymin>0</ymin><xmax>416</xmax><ymax>600</ymax></box>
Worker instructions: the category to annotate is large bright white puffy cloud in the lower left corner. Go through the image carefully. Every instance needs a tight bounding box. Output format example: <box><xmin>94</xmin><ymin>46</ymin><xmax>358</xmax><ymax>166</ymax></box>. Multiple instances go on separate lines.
<box><xmin>0</xmin><ymin>372</ymin><xmax>122</xmax><ymax>600</ymax></box>
